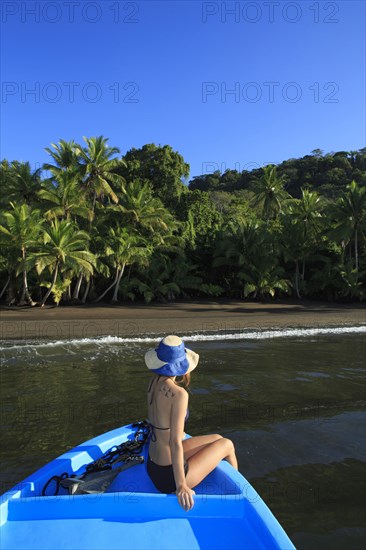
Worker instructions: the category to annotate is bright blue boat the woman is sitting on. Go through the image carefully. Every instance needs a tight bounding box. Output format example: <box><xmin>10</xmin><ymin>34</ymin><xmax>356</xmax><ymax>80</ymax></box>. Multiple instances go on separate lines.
<box><xmin>0</xmin><ymin>424</ymin><xmax>295</xmax><ymax>550</ymax></box>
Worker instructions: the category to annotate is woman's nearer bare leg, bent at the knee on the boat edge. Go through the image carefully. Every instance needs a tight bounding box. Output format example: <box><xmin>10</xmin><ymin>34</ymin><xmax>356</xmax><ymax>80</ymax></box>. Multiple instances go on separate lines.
<box><xmin>186</xmin><ymin>437</ymin><xmax>238</xmax><ymax>489</ymax></box>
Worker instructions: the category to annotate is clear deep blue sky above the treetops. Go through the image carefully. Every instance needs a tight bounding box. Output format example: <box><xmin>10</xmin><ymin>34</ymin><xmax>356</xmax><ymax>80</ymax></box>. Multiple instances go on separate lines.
<box><xmin>1</xmin><ymin>0</ymin><xmax>365</xmax><ymax>177</ymax></box>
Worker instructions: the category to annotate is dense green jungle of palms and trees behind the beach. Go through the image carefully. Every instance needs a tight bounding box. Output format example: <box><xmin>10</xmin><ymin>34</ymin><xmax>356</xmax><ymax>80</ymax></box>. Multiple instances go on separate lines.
<box><xmin>0</xmin><ymin>136</ymin><xmax>366</xmax><ymax>307</ymax></box>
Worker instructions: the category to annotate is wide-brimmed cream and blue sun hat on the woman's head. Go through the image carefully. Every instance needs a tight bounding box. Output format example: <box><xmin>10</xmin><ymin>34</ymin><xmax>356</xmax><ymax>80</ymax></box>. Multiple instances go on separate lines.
<box><xmin>145</xmin><ymin>334</ymin><xmax>199</xmax><ymax>376</ymax></box>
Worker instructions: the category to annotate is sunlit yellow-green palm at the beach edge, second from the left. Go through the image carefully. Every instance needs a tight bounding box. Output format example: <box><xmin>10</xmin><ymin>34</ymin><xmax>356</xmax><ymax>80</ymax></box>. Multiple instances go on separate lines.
<box><xmin>35</xmin><ymin>218</ymin><xmax>95</xmax><ymax>307</ymax></box>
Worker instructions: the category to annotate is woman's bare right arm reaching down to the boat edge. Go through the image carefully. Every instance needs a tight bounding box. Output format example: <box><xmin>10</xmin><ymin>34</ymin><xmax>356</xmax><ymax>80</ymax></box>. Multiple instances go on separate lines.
<box><xmin>170</xmin><ymin>390</ymin><xmax>195</xmax><ymax>510</ymax></box>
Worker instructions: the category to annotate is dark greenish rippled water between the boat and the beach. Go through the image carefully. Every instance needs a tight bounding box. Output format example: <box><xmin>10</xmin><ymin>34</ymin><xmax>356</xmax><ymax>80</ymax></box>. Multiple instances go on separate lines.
<box><xmin>0</xmin><ymin>330</ymin><xmax>366</xmax><ymax>550</ymax></box>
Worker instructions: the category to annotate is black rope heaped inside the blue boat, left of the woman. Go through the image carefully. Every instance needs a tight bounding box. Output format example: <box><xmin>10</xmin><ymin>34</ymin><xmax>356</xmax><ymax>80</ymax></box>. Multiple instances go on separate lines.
<box><xmin>42</xmin><ymin>420</ymin><xmax>150</xmax><ymax>496</ymax></box>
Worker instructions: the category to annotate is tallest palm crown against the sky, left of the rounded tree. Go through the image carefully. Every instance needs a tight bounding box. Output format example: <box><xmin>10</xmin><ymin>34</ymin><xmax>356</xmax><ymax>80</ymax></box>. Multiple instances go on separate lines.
<box><xmin>75</xmin><ymin>136</ymin><xmax>126</xmax><ymax>212</ymax></box>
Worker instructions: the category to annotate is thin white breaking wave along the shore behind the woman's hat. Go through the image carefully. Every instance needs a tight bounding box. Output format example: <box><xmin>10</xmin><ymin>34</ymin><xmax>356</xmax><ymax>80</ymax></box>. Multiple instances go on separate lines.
<box><xmin>0</xmin><ymin>325</ymin><xmax>366</xmax><ymax>352</ymax></box>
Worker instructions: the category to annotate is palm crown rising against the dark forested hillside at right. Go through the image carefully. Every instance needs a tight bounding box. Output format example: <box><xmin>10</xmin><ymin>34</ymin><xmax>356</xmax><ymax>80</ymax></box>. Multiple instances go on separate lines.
<box><xmin>252</xmin><ymin>164</ymin><xmax>289</xmax><ymax>220</ymax></box>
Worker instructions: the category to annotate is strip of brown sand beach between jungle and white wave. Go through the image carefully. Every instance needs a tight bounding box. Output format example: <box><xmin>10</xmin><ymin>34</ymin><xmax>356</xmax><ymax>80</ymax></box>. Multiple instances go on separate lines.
<box><xmin>0</xmin><ymin>300</ymin><xmax>366</xmax><ymax>341</ymax></box>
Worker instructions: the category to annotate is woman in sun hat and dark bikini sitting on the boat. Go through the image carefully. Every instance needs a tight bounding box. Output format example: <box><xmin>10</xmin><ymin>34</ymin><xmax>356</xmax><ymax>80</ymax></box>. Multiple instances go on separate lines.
<box><xmin>145</xmin><ymin>335</ymin><xmax>238</xmax><ymax>510</ymax></box>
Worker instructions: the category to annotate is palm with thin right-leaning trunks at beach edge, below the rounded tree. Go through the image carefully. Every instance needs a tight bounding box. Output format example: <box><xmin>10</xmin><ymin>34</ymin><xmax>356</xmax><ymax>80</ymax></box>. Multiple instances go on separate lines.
<box><xmin>94</xmin><ymin>227</ymin><xmax>152</xmax><ymax>302</ymax></box>
